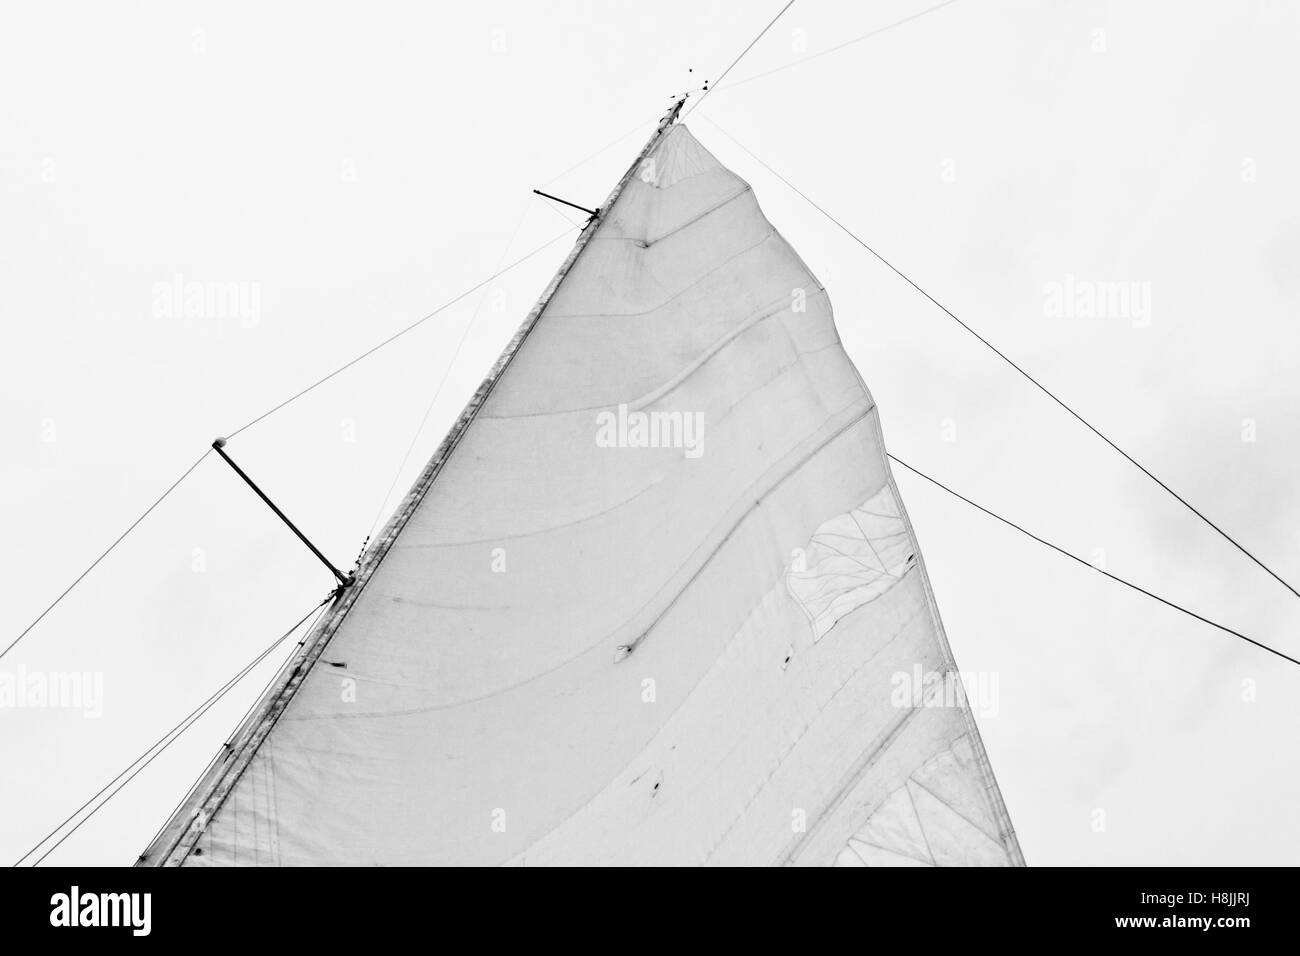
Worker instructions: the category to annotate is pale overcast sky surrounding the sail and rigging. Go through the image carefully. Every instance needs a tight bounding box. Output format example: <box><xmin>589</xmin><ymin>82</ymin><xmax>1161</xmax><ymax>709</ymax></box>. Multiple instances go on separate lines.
<box><xmin>0</xmin><ymin>0</ymin><xmax>1300</xmax><ymax>864</ymax></box>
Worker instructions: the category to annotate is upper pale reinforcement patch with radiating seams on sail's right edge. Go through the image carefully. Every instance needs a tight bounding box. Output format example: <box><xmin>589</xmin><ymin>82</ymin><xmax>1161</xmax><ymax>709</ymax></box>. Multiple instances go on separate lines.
<box><xmin>785</xmin><ymin>485</ymin><xmax>917</xmax><ymax>641</ymax></box>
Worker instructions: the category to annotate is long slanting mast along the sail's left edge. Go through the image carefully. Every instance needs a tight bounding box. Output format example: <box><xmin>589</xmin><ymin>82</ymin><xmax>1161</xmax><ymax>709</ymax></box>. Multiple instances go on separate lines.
<box><xmin>137</xmin><ymin>96</ymin><xmax>686</xmax><ymax>866</ymax></box>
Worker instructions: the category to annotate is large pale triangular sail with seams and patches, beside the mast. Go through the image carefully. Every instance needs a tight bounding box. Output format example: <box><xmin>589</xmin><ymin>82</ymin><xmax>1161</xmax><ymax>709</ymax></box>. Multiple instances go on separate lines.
<box><xmin>143</xmin><ymin>104</ymin><xmax>1022</xmax><ymax>866</ymax></box>
